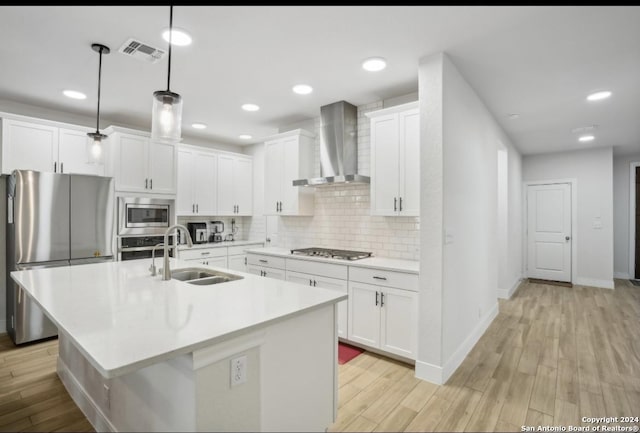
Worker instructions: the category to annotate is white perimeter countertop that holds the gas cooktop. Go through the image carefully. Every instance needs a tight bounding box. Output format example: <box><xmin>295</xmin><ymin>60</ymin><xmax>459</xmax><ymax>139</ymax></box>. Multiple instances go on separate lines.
<box><xmin>246</xmin><ymin>247</ymin><xmax>420</xmax><ymax>274</ymax></box>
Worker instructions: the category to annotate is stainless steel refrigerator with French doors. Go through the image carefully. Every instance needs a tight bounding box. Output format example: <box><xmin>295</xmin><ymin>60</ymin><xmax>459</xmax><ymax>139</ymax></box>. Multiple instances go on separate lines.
<box><xmin>6</xmin><ymin>170</ymin><xmax>115</xmax><ymax>344</ymax></box>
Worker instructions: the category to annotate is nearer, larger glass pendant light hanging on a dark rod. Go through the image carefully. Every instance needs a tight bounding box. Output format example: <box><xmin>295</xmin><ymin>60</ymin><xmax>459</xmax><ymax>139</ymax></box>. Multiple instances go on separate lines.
<box><xmin>151</xmin><ymin>5</ymin><xmax>182</xmax><ymax>143</ymax></box>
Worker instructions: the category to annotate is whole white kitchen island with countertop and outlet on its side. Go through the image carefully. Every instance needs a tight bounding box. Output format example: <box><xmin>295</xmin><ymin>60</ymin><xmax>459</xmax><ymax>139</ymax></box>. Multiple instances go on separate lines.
<box><xmin>11</xmin><ymin>259</ymin><xmax>346</xmax><ymax>431</ymax></box>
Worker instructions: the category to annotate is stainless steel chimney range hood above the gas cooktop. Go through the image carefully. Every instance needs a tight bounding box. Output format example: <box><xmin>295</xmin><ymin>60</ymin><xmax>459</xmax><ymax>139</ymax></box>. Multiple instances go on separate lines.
<box><xmin>293</xmin><ymin>101</ymin><xmax>369</xmax><ymax>186</ymax></box>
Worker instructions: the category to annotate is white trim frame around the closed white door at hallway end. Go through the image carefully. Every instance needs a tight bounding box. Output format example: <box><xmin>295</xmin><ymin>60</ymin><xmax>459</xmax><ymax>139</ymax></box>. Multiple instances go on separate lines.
<box><xmin>522</xmin><ymin>178</ymin><xmax>578</xmax><ymax>284</ymax></box>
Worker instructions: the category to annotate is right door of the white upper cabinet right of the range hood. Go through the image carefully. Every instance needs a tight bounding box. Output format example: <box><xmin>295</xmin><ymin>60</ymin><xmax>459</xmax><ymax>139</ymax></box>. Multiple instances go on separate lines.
<box><xmin>398</xmin><ymin>109</ymin><xmax>420</xmax><ymax>216</ymax></box>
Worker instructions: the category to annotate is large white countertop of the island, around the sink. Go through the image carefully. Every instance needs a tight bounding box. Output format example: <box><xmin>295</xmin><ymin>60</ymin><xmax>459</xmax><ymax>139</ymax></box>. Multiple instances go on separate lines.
<box><xmin>11</xmin><ymin>258</ymin><xmax>347</xmax><ymax>377</ymax></box>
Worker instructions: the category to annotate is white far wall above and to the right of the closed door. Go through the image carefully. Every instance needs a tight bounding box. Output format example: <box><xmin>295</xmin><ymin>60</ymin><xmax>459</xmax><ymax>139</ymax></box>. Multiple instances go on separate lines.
<box><xmin>522</xmin><ymin>147</ymin><xmax>613</xmax><ymax>288</ymax></box>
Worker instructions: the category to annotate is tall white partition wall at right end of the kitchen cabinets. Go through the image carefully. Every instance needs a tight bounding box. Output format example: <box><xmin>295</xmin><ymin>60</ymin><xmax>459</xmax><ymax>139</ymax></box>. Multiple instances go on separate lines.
<box><xmin>416</xmin><ymin>54</ymin><xmax>521</xmax><ymax>383</ymax></box>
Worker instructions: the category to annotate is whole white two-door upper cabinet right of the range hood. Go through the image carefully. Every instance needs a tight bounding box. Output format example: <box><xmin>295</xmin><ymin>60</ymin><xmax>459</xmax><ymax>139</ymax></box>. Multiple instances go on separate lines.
<box><xmin>366</xmin><ymin>101</ymin><xmax>420</xmax><ymax>216</ymax></box>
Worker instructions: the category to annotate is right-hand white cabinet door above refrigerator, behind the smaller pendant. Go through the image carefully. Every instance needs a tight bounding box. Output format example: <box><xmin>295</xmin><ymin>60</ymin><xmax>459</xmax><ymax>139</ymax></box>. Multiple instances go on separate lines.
<box><xmin>58</xmin><ymin>128</ymin><xmax>108</xmax><ymax>176</ymax></box>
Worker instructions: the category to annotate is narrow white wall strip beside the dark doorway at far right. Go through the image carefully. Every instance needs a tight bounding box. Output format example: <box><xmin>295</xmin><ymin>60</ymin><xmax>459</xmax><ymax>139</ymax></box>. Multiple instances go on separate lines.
<box><xmin>613</xmin><ymin>153</ymin><xmax>640</xmax><ymax>278</ymax></box>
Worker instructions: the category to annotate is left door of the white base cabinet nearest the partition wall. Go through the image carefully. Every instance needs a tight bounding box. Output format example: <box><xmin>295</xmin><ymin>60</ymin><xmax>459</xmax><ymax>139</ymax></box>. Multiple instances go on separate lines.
<box><xmin>348</xmin><ymin>282</ymin><xmax>380</xmax><ymax>347</ymax></box>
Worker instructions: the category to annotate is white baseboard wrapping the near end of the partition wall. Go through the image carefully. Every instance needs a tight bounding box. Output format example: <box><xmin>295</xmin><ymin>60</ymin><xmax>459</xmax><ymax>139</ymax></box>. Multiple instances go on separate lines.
<box><xmin>416</xmin><ymin>302</ymin><xmax>498</xmax><ymax>385</ymax></box>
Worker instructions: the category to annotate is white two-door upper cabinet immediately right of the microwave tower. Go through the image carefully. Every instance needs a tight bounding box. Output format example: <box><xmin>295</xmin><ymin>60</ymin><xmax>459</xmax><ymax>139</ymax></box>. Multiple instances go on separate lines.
<box><xmin>176</xmin><ymin>145</ymin><xmax>218</xmax><ymax>216</ymax></box>
